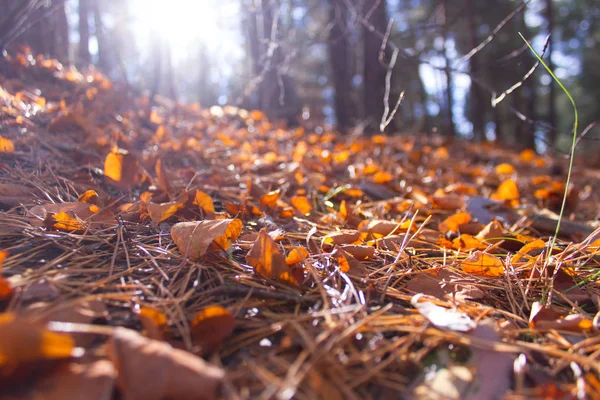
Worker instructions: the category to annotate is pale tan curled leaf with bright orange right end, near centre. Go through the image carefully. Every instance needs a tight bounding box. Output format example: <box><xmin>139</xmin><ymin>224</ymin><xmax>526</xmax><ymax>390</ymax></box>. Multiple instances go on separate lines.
<box><xmin>171</xmin><ymin>219</ymin><xmax>242</xmax><ymax>260</ymax></box>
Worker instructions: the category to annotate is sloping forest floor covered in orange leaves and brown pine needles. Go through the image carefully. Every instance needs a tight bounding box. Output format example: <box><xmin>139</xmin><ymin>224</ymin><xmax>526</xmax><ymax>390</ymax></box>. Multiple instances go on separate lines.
<box><xmin>0</xmin><ymin>50</ymin><xmax>600</xmax><ymax>399</ymax></box>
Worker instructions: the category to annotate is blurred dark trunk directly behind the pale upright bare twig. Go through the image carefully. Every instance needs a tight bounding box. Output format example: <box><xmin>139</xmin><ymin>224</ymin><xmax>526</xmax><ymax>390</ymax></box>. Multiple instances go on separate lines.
<box><xmin>362</xmin><ymin>0</ymin><xmax>394</xmax><ymax>130</ymax></box>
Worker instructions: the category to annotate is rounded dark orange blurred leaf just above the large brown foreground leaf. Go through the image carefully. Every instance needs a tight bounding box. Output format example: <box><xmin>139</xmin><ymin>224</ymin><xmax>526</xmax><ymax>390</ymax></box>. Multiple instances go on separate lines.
<box><xmin>190</xmin><ymin>306</ymin><xmax>235</xmax><ymax>353</ymax></box>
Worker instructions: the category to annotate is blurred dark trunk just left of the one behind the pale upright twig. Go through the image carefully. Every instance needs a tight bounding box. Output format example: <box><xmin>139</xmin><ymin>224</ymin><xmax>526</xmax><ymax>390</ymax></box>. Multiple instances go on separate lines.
<box><xmin>328</xmin><ymin>0</ymin><xmax>353</xmax><ymax>132</ymax></box>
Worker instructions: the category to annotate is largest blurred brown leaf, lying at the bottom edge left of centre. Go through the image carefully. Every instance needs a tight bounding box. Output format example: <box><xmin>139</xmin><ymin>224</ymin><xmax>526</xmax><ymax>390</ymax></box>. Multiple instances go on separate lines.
<box><xmin>109</xmin><ymin>328</ymin><xmax>224</xmax><ymax>400</ymax></box>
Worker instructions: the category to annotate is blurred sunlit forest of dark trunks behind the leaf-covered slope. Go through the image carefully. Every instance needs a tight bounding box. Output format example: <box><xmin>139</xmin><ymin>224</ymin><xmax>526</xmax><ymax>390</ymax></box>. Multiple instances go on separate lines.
<box><xmin>0</xmin><ymin>0</ymin><xmax>600</xmax><ymax>158</ymax></box>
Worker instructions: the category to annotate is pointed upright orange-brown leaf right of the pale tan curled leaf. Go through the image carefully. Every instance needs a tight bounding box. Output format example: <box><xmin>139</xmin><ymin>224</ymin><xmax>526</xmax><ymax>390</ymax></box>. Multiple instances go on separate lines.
<box><xmin>246</xmin><ymin>228</ymin><xmax>299</xmax><ymax>285</ymax></box>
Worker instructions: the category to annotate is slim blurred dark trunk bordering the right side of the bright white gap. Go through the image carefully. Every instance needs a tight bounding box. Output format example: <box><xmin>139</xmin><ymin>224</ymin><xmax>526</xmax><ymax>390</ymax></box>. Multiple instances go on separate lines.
<box><xmin>467</xmin><ymin>0</ymin><xmax>486</xmax><ymax>141</ymax></box>
